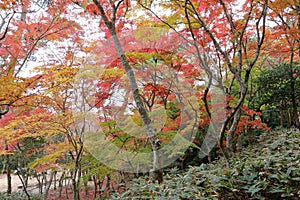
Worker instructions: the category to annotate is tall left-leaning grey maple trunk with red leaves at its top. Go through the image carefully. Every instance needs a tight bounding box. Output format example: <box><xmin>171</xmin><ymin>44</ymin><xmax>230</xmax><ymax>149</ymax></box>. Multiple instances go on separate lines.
<box><xmin>85</xmin><ymin>0</ymin><xmax>163</xmax><ymax>182</ymax></box>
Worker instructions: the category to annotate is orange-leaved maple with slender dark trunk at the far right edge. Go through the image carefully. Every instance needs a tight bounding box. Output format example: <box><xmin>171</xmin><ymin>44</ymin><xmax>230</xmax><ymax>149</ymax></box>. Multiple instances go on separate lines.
<box><xmin>266</xmin><ymin>1</ymin><xmax>300</xmax><ymax>127</ymax></box>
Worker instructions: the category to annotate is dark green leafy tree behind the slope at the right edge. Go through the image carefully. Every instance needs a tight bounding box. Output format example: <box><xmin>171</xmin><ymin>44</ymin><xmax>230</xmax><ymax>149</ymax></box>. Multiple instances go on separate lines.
<box><xmin>255</xmin><ymin>63</ymin><xmax>300</xmax><ymax>128</ymax></box>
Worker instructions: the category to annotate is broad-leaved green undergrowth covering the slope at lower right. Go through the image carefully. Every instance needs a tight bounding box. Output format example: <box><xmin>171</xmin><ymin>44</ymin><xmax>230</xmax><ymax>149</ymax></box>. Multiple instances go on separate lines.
<box><xmin>111</xmin><ymin>132</ymin><xmax>300</xmax><ymax>200</ymax></box>
